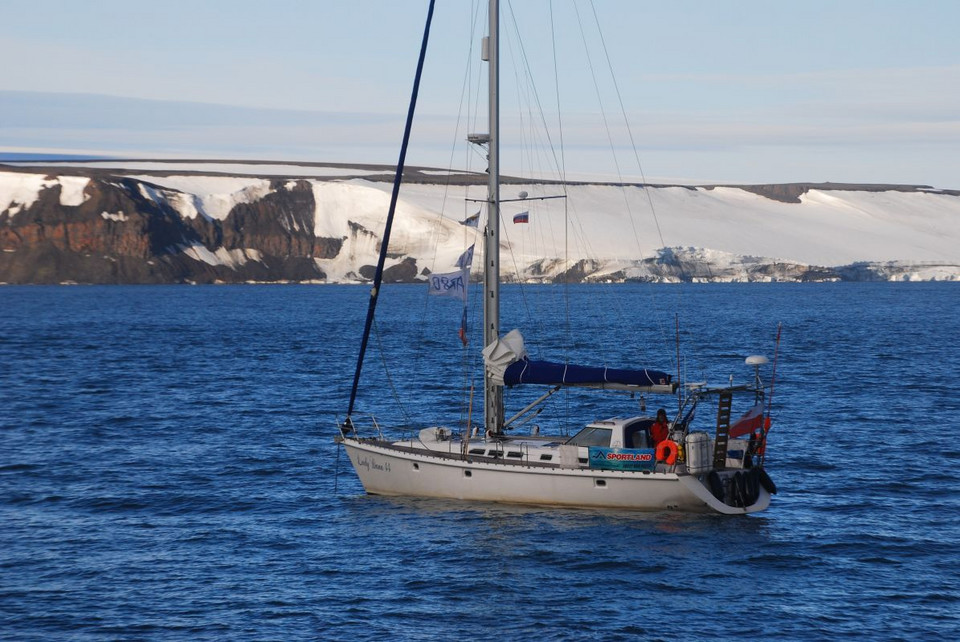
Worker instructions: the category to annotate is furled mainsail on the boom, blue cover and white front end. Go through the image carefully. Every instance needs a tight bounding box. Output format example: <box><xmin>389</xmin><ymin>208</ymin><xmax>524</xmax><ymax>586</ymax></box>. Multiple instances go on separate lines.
<box><xmin>483</xmin><ymin>330</ymin><xmax>676</xmax><ymax>393</ymax></box>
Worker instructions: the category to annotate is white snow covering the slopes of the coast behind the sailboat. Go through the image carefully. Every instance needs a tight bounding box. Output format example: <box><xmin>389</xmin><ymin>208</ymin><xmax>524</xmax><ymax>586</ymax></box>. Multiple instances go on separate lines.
<box><xmin>0</xmin><ymin>168</ymin><xmax>960</xmax><ymax>282</ymax></box>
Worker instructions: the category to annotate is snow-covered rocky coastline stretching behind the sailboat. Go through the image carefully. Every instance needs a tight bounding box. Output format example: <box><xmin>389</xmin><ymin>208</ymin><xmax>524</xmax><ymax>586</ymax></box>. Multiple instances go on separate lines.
<box><xmin>0</xmin><ymin>162</ymin><xmax>960</xmax><ymax>283</ymax></box>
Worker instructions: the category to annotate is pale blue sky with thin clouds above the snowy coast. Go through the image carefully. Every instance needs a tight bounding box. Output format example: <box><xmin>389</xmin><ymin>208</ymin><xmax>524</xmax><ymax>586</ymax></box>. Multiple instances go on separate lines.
<box><xmin>0</xmin><ymin>0</ymin><xmax>960</xmax><ymax>189</ymax></box>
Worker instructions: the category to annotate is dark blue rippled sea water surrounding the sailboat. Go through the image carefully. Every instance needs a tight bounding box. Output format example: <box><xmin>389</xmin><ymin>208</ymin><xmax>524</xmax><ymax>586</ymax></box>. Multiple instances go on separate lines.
<box><xmin>0</xmin><ymin>283</ymin><xmax>960</xmax><ymax>641</ymax></box>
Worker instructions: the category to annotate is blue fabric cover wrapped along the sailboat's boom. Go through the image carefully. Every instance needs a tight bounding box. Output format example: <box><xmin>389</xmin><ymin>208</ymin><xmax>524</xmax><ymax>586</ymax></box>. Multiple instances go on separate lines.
<box><xmin>503</xmin><ymin>359</ymin><xmax>670</xmax><ymax>388</ymax></box>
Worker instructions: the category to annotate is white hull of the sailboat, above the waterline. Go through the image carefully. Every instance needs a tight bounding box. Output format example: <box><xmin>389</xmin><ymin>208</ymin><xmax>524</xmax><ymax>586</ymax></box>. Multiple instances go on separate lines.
<box><xmin>343</xmin><ymin>437</ymin><xmax>770</xmax><ymax>514</ymax></box>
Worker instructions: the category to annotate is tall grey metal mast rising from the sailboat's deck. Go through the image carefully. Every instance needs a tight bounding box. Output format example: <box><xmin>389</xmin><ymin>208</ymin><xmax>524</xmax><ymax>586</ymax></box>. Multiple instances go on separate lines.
<box><xmin>483</xmin><ymin>0</ymin><xmax>503</xmax><ymax>433</ymax></box>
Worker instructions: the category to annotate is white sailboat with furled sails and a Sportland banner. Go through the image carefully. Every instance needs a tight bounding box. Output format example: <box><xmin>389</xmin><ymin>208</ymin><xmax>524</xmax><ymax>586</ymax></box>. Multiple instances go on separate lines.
<box><xmin>336</xmin><ymin>0</ymin><xmax>779</xmax><ymax>515</ymax></box>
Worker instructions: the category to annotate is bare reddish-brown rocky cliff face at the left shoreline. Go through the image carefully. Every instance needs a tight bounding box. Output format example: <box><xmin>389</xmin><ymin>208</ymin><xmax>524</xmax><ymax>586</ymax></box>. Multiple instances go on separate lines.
<box><xmin>0</xmin><ymin>177</ymin><xmax>342</xmax><ymax>283</ymax></box>
